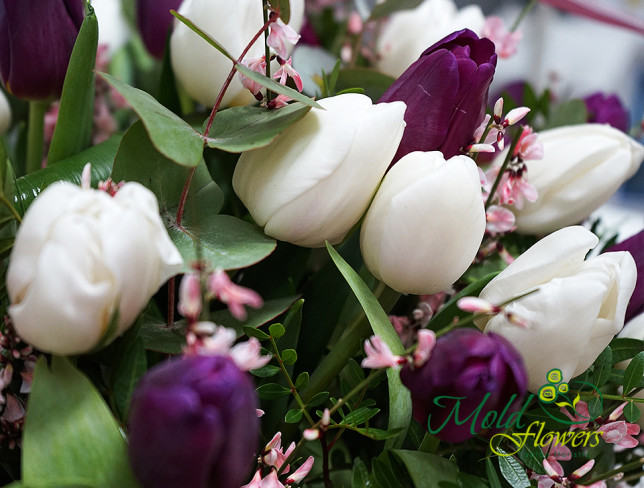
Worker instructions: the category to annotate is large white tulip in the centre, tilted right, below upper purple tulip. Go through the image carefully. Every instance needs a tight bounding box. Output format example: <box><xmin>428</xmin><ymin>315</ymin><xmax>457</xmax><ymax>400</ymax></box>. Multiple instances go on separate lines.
<box><xmin>233</xmin><ymin>93</ymin><xmax>406</xmax><ymax>247</ymax></box>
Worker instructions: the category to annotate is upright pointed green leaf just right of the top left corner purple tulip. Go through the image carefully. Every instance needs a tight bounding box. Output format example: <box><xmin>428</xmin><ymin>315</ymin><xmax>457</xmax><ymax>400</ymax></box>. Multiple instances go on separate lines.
<box><xmin>47</xmin><ymin>7</ymin><xmax>98</xmax><ymax>164</ymax></box>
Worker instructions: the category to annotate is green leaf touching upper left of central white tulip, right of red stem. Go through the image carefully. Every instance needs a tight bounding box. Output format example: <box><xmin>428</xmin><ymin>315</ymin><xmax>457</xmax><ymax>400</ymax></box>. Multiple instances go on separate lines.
<box><xmin>206</xmin><ymin>103</ymin><xmax>311</xmax><ymax>153</ymax></box>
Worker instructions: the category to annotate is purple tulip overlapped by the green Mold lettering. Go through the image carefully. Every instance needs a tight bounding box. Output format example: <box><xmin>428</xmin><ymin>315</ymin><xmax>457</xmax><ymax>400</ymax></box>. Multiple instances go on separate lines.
<box><xmin>400</xmin><ymin>329</ymin><xmax>528</xmax><ymax>442</ymax></box>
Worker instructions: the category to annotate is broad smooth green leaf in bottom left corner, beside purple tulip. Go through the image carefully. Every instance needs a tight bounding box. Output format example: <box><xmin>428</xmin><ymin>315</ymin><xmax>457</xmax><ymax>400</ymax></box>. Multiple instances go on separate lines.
<box><xmin>22</xmin><ymin>356</ymin><xmax>139</xmax><ymax>488</ymax></box>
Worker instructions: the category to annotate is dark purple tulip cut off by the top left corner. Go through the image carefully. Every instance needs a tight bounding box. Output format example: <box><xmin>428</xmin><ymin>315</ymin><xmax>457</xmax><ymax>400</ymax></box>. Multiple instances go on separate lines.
<box><xmin>0</xmin><ymin>0</ymin><xmax>85</xmax><ymax>100</ymax></box>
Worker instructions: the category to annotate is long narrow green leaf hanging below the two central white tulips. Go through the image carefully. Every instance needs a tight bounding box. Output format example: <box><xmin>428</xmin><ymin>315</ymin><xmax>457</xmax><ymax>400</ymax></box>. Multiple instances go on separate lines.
<box><xmin>326</xmin><ymin>242</ymin><xmax>411</xmax><ymax>446</ymax></box>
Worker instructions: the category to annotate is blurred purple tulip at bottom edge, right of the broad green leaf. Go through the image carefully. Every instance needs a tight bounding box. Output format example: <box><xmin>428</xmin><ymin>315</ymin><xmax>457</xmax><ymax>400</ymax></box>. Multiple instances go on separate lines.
<box><xmin>129</xmin><ymin>356</ymin><xmax>259</xmax><ymax>488</ymax></box>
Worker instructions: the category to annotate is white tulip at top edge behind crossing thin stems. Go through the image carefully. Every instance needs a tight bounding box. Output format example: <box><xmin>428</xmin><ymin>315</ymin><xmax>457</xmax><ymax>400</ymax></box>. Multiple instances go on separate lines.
<box><xmin>170</xmin><ymin>0</ymin><xmax>304</xmax><ymax>107</ymax></box>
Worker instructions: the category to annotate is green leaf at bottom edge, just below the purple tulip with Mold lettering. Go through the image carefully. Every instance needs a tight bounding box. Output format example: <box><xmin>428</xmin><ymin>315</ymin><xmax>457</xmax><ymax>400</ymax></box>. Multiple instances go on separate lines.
<box><xmin>391</xmin><ymin>449</ymin><xmax>458</xmax><ymax>488</ymax></box>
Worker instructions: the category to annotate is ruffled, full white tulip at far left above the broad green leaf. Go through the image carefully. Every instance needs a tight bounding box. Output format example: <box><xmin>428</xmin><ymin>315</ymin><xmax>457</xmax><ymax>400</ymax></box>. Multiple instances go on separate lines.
<box><xmin>7</xmin><ymin>182</ymin><xmax>182</xmax><ymax>355</ymax></box>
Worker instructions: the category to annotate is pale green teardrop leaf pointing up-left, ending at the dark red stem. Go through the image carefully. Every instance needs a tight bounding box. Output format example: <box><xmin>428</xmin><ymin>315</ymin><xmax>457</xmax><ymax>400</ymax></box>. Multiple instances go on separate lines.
<box><xmin>99</xmin><ymin>73</ymin><xmax>204</xmax><ymax>168</ymax></box>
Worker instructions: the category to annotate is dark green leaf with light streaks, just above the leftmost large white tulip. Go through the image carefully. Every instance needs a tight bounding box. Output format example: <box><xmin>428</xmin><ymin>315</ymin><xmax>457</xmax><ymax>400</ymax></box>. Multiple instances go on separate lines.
<box><xmin>11</xmin><ymin>136</ymin><xmax>121</xmax><ymax>215</ymax></box>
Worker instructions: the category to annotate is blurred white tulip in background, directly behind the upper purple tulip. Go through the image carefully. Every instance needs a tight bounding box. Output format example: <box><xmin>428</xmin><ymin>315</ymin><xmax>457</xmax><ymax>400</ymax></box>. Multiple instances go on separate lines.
<box><xmin>377</xmin><ymin>0</ymin><xmax>485</xmax><ymax>78</ymax></box>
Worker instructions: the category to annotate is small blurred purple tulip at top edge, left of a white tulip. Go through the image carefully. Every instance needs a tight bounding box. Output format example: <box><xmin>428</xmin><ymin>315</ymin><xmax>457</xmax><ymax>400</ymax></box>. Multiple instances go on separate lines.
<box><xmin>136</xmin><ymin>0</ymin><xmax>182</xmax><ymax>59</ymax></box>
